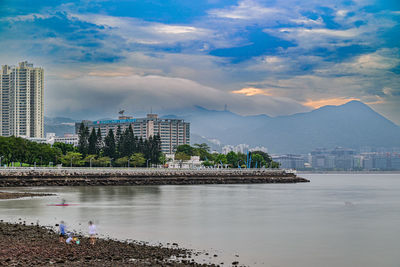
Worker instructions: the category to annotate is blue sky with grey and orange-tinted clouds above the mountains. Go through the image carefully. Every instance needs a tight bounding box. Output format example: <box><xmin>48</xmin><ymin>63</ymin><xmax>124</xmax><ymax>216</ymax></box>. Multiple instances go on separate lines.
<box><xmin>0</xmin><ymin>0</ymin><xmax>400</xmax><ymax>125</ymax></box>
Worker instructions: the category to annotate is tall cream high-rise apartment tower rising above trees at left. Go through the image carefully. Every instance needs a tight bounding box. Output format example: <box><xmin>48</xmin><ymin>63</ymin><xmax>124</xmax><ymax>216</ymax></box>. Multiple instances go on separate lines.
<box><xmin>0</xmin><ymin>61</ymin><xmax>44</xmax><ymax>138</ymax></box>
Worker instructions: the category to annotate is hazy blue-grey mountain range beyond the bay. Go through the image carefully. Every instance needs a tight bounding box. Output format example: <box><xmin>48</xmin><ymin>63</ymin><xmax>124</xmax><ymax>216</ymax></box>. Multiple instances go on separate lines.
<box><xmin>45</xmin><ymin>101</ymin><xmax>400</xmax><ymax>153</ymax></box>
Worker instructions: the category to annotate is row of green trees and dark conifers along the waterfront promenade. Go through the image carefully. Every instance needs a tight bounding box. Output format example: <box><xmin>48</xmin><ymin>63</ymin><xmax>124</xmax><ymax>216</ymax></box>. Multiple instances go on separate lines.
<box><xmin>0</xmin><ymin>124</ymin><xmax>279</xmax><ymax>168</ymax></box>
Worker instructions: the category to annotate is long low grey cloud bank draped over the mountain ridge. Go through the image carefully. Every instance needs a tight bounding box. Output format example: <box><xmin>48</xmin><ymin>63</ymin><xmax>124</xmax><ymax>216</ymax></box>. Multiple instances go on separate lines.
<box><xmin>47</xmin><ymin>71</ymin><xmax>305</xmax><ymax>119</ymax></box>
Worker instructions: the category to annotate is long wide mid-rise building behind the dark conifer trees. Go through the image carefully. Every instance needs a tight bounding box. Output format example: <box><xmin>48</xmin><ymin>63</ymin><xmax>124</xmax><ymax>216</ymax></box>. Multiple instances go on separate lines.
<box><xmin>75</xmin><ymin>114</ymin><xmax>190</xmax><ymax>154</ymax></box>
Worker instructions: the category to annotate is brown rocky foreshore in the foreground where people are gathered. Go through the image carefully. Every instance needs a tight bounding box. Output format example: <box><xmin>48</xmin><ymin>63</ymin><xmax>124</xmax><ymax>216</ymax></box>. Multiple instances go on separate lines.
<box><xmin>0</xmin><ymin>222</ymin><xmax>215</xmax><ymax>267</ymax></box>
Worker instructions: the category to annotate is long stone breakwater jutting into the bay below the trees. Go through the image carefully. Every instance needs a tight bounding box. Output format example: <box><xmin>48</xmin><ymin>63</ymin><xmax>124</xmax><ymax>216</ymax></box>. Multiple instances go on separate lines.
<box><xmin>0</xmin><ymin>168</ymin><xmax>309</xmax><ymax>187</ymax></box>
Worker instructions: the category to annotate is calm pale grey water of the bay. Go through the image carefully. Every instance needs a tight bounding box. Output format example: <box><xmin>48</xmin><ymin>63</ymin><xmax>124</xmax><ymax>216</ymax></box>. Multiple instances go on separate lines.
<box><xmin>0</xmin><ymin>174</ymin><xmax>400</xmax><ymax>267</ymax></box>
